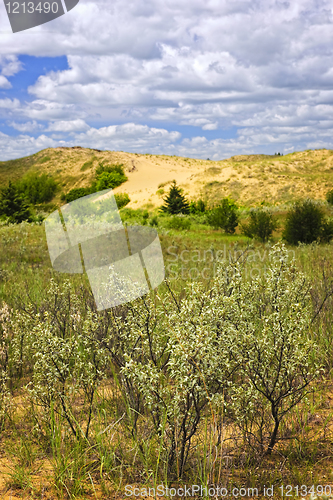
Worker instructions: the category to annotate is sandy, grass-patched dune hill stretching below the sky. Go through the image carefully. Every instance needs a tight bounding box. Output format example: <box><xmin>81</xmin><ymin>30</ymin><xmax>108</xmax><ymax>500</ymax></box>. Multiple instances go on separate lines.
<box><xmin>0</xmin><ymin>146</ymin><xmax>333</xmax><ymax>208</ymax></box>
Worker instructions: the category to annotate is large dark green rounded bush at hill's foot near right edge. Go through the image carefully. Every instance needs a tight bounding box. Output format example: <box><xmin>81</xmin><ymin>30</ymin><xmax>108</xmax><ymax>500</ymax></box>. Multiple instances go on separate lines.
<box><xmin>282</xmin><ymin>200</ymin><xmax>325</xmax><ymax>245</ymax></box>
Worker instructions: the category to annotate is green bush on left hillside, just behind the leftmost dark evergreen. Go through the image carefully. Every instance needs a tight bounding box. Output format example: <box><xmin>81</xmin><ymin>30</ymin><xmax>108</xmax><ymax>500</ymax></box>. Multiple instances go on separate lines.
<box><xmin>16</xmin><ymin>173</ymin><xmax>58</xmax><ymax>204</ymax></box>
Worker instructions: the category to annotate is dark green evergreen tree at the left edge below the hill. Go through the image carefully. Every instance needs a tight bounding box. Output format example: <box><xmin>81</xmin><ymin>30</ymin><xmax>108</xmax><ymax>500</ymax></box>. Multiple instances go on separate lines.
<box><xmin>0</xmin><ymin>182</ymin><xmax>33</xmax><ymax>223</ymax></box>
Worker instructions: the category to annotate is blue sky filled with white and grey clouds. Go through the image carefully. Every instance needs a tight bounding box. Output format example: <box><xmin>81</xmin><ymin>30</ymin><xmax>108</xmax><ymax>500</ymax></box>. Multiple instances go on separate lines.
<box><xmin>0</xmin><ymin>0</ymin><xmax>333</xmax><ymax>160</ymax></box>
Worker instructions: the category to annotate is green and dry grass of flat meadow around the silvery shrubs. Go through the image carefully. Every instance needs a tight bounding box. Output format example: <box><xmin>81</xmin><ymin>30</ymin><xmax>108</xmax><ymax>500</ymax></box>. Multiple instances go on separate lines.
<box><xmin>0</xmin><ymin>218</ymin><xmax>333</xmax><ymax>499</ymax></box>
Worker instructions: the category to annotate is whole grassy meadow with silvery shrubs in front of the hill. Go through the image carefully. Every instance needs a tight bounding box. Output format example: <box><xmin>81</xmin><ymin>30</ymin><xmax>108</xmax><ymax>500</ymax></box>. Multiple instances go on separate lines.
<box><xmin>0</xmin><ymin>211</ymin><xmax>333</xmax><ymax>499</ymax></box>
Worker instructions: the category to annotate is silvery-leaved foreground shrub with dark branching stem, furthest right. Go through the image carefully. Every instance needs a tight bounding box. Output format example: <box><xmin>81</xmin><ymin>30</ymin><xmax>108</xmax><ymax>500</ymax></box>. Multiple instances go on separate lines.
<box><xmin>228</xmin><ymin>242</ymin><xmax>320</xmax><ymax>455</ymax></box>
